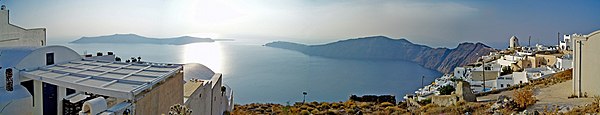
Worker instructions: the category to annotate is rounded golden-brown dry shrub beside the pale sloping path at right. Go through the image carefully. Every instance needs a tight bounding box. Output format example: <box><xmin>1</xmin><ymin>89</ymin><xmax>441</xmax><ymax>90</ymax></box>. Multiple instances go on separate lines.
<box><xmin>513</xmin><ymin>88</ymin><xmax>536</xmax><ymax>110</ymax></box>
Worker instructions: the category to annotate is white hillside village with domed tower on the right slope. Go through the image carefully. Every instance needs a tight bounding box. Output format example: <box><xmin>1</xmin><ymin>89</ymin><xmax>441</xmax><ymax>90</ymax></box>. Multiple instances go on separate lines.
<box><xmin>404</xmin><ymin>30</ymin><xmax>600</xmax><ymax>108</ymax></box>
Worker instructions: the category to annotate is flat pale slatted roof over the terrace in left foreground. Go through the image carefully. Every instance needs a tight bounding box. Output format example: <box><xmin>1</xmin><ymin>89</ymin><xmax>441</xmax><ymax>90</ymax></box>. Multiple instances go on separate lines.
<box><xmin>21</xmin><ymin>59</ymin><xmax>182</xmax><ymax>100</ymax></box>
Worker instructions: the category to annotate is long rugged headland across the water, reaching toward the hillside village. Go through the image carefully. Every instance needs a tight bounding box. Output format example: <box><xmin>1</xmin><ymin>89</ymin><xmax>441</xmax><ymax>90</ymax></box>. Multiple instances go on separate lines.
<box><xmin>264</xmin><ymin>36</ymin><xmax>495</xmax><ymax>73</ymax></box>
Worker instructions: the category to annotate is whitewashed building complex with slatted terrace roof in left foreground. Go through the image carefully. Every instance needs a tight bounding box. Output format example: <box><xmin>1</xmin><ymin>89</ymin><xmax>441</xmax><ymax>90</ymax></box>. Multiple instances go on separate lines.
<box><xmin>0</xmin><ymin>6</ymin><xmax>234</xmax><ymax>115</ymax></box>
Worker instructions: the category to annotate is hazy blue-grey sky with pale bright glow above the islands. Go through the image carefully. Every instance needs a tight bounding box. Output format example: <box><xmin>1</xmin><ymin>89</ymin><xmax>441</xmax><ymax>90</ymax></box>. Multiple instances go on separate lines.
<box><xmin>0</xmin><ymin>0</ymin><xmax>600</xmax><ymax>48</ymax></box>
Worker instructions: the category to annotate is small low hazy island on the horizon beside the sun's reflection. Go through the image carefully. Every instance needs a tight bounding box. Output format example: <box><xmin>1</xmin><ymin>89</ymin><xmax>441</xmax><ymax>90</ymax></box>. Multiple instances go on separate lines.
<box><xmin>70</xmin><ymin>34</ymin><xmax>232</xmax><ymax>45</ymax></box>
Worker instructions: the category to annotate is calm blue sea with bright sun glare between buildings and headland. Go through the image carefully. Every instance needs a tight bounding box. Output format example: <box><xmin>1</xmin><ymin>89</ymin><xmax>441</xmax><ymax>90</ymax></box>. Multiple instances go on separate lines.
<box><xmin>54</xmin><ymin>41</ymin><xmax>441</xmax><ymax>104</ymax></box>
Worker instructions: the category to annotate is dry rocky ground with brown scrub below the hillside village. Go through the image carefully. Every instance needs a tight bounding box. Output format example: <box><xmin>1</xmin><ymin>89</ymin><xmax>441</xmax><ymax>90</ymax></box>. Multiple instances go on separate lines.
<box><xmin>232</xmin><ymin>71</ymin><xmax>600</xmax><ymax>115</ymax></box>
